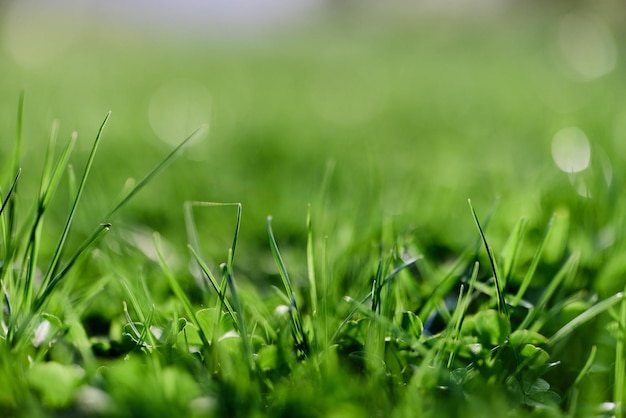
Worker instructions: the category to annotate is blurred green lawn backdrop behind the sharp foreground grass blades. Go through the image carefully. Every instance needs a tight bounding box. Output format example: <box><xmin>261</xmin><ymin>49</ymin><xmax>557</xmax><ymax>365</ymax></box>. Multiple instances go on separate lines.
<box><xmin>0</xmin><ymin>0</ymin><xmax>626</xmax><ymax>288</ymax></box>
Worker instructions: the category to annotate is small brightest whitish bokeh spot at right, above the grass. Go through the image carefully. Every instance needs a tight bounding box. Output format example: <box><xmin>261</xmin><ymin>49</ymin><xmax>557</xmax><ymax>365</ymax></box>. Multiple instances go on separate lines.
<box><xmin>552</xmin><ymin>126</ymin><xmax>591</xmax><ymax>173</ymax></box>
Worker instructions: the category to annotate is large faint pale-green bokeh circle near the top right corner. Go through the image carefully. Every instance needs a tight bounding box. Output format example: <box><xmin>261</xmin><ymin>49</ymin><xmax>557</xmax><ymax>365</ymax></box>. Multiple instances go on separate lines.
<box><xmin>558</xmin><ymin>12</ymin><xmax>617</xmax><ymax>80</ymax></box>
